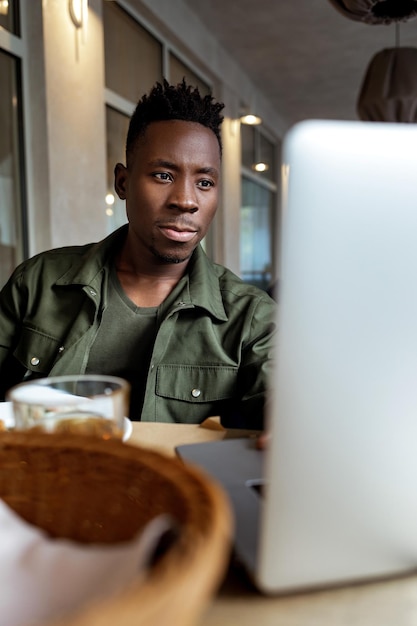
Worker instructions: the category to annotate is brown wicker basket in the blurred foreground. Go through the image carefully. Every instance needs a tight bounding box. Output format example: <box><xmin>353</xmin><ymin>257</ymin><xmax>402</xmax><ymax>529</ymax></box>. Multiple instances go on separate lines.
<box><xmin>0</xmin><ymin>432</ymin><xmax>232</xmax><ymax>626</ymax></box>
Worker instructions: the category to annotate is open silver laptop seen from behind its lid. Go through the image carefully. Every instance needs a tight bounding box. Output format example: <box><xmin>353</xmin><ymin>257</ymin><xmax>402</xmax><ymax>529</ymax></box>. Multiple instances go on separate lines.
<box><xmin>178</xmin><ymin>121</ymin><xmax>417</xmax><ymax>593</ymax></box>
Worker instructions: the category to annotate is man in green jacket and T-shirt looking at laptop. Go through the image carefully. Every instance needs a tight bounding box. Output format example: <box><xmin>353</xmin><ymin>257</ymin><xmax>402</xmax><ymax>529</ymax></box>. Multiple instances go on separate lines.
<box><xmin>0</xmin><ymin>81</ymin><xmax>274</xmax><ymax>428</ymax></box>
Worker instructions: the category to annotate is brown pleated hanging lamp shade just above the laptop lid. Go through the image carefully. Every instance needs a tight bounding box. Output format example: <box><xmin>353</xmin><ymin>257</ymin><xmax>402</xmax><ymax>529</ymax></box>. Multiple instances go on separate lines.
<box><xmin>357</xmin><ymin>47</ymin><xmax>417</xmax><ymax>123</ymax></box>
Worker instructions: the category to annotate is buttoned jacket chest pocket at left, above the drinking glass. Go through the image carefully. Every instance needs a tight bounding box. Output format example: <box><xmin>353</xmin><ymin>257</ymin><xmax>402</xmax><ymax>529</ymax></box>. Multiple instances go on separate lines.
<box><xmin>14</xmin><ymin>326</ymin><xmax>60</xmax><ymax>374</ymax></box>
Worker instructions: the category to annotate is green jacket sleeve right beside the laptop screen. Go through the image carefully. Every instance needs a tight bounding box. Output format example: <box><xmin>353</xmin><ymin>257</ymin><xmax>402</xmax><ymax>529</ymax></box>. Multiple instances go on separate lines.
<box><xmin>221</xmin><ymin>295</ymin><xmax>277</xmax><ymax>430</ymax></box>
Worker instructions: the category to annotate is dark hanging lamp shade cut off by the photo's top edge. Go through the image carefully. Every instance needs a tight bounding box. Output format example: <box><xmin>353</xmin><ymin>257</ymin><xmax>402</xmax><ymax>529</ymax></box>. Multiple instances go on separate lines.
<box><xmin>329</xmin><ymin>0</ymin><xmax>417</xmax><ymax>24</ymax></box>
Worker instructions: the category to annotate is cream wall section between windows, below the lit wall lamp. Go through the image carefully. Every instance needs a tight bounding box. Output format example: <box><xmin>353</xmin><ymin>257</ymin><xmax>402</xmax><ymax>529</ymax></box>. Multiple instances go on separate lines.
<box><xmin>26</xmin><ymin>0</ymin><xmax>106</xmax><ymax>254</ymax></box>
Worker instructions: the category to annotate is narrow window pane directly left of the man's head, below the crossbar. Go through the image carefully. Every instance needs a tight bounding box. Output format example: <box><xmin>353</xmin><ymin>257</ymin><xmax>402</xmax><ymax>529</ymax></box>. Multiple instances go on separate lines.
<box><xmin>105</xmin><ymin>107</ymin><xmax>129</xmax><ymax>233</ymax></box>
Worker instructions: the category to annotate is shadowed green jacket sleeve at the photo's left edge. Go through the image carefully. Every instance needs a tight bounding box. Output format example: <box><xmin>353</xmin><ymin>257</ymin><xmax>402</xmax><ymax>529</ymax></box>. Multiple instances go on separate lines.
<box><xmin>0</xmin><ymin>268</ymin><xmax>25</xmax><ymax>401</ymax></box>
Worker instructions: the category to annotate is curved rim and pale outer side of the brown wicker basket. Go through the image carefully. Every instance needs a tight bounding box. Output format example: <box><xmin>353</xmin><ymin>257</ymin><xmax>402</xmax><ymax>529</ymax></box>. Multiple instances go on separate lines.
<box><xmin>0</xmin><ymin>432</ymin><xmax>233</xmax><ymax>626</ymax></box>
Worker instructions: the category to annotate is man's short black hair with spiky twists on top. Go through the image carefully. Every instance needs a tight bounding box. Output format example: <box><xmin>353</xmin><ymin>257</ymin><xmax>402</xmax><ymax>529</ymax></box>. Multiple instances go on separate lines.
<box><xmin>126</xmin><ymin>78</ymin><xmax>224</xmax><ymax>161</ymax></box>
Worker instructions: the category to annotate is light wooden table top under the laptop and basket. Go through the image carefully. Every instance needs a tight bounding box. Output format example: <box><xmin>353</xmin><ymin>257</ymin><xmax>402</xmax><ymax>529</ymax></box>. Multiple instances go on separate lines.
<box><xmin>130</xmin><ymin>418</ymin><xmax>417</xmax><ymax>626</ymax></box>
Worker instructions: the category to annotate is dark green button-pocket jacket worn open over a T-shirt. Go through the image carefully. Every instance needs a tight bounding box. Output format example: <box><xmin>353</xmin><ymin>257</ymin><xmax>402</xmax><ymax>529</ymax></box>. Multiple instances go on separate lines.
<box><xmin>0</xmin><ymin>227</ymin><xmax>275</xmax><ymax>428</ymax></box>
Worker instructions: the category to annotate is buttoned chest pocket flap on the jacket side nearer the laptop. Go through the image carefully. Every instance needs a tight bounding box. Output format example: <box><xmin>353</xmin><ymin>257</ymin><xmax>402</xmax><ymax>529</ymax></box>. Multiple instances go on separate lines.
<box><xmin>155</xmin><ymin>365</ymin><xmax>238</xmax><ymax>404</ymax></box>
